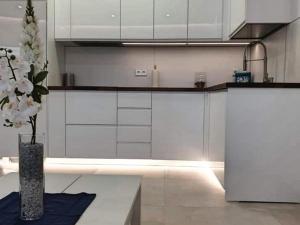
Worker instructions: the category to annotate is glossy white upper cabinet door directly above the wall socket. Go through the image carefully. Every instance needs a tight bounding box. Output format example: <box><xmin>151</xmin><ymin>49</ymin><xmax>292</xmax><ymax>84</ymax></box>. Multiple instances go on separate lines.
<box><xmin>121</xmin><ymin>0</ymin><xmax>153</xmax><ymax>39</ymax></box>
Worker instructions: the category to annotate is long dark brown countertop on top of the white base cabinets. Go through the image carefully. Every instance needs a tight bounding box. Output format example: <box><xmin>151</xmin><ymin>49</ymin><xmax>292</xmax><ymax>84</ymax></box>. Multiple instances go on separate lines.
<box><xmin>48</xmin><ymin>83</ymin><xmax>300</xmax><ymax>92</ymax></box>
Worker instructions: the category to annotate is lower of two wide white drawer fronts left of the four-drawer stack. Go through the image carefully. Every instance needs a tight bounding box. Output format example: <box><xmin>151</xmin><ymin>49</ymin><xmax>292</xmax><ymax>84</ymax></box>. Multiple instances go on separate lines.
<box><xmin>66</xmin><ymin>125</ymin><xmax>117</xmax><ymax>158</ymax></box>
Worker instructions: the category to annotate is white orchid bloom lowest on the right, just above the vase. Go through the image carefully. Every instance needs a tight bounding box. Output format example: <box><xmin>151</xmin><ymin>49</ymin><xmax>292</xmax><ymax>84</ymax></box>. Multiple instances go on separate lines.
<box><xmin>18</xmin><ymin>95</ymin><xmax>40</xmax><ymax>117</ymax></box>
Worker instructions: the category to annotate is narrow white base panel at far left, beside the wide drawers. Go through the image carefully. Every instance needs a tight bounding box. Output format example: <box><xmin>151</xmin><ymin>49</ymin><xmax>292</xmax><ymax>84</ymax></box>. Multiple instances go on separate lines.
<box><xmin>48</xmin><ymin>91</ymin><xmax>66</xmax><ymax>158</ymax></box>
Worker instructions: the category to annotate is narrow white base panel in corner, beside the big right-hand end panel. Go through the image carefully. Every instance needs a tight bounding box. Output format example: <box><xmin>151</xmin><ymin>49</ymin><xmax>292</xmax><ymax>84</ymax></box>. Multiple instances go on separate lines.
<box><xmin>208</xmin><ymin>92</ymin><xmax>227</xmax><ymax>162</ymax></box>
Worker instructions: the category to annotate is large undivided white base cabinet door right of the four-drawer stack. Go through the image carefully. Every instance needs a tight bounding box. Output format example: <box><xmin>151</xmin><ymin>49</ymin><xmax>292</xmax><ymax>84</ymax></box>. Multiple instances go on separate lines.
<box><xmin>152</xmin><ymin>93</ymin><xmax>204</xmax><ymax>161</ymax></box>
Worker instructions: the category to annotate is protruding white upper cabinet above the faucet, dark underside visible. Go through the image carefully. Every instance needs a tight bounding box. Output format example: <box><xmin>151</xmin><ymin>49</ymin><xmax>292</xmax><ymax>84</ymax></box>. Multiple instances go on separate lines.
<box><xmin>229</xmin><ymin>0</ymin><xmax>295</xmax><ymax>39</ymax></box>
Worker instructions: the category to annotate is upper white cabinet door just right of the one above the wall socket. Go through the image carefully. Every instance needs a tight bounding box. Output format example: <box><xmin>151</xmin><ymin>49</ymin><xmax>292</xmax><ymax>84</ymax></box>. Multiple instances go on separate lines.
<box><xmin>154</xmin><ymin>0</ymin><xmax>188</xmax><ymax>40</ymax></box>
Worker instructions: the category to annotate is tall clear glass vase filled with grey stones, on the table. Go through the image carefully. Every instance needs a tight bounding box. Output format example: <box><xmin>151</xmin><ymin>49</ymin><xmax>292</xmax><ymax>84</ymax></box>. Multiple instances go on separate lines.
<box><xmin>19</xmin><ymin>134</ymin><xmax>45</xmax><ymax>220</ymax></box>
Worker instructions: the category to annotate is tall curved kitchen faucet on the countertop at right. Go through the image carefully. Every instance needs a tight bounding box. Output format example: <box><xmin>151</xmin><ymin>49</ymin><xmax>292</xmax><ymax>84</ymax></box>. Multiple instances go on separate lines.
<box><xmin>243</xmin><ymin>41</ymin><xmax>274</xmax><ymax>83</ymax></box>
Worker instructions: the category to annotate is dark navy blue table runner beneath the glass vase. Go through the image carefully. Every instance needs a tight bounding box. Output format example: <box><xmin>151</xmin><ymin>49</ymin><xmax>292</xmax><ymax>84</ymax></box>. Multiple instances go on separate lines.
<box><xmin>0</xmin><ymin>192</ymin><xmax>96</xmax><ymax>225</ymax></box>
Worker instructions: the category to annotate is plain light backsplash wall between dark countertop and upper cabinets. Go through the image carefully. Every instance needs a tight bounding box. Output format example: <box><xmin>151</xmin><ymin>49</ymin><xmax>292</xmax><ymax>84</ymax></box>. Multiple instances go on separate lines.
<box><xmin>65</xmin><ymin>47</ymin><xmax>243</xmax><ymax>87</ymax></box>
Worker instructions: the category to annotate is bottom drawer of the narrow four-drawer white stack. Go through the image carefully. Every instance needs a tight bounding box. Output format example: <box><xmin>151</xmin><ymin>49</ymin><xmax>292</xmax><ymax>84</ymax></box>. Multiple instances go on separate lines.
<box><xmin>117</xmin><ymin>143</ymin><xmax>151</xmax><ymax>159</ymax></box>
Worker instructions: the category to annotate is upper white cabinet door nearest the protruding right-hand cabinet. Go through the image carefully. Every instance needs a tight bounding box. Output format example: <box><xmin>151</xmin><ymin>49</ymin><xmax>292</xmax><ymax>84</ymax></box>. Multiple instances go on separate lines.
<box><xmin>188</xmin><ymin>0</ymin><xmax>223</xmax><ymax>39</ymax></box>
